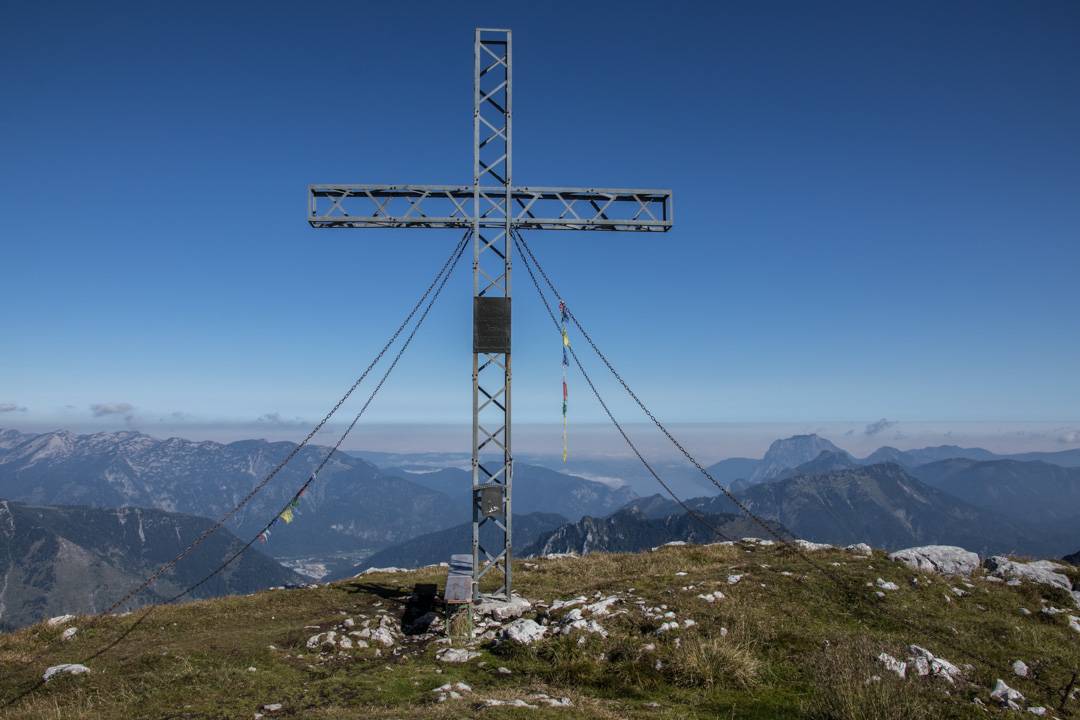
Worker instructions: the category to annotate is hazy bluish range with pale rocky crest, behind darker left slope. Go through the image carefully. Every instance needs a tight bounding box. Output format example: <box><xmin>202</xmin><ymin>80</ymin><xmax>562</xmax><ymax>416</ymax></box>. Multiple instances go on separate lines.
<box><xmin>0</xmin><ymin>431</ymin><xmax>634</xmax><ymax>559</ymax></box>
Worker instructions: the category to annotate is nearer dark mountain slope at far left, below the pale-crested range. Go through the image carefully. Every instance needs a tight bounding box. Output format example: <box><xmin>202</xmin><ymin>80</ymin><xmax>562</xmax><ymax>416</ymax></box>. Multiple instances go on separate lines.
<box><xmin>0</xmin><ymin>500</ymin><xmax>300</xmax><ymax>630</ymax></box>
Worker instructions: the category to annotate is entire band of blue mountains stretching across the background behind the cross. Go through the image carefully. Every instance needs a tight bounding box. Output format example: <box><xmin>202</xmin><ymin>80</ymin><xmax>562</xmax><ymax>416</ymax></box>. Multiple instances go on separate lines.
<box><xmin>0</xmin><ymin>430</ymin><xmax>1080</xmax><ymax>624</ymax></box>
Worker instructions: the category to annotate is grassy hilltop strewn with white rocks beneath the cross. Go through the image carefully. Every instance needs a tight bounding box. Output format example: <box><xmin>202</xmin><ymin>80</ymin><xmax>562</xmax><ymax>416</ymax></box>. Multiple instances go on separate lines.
<box><xmin>0</xmin><ymin>543</ymin><xmax>1080</xmax><ymax>720</ymax></box>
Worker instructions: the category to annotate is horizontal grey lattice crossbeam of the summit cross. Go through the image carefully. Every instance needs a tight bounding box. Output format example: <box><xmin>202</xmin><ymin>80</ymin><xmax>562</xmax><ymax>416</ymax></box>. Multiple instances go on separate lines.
<box><xmin>308</xmin><ymin>185</ymin><xmax>674</xmax><ymax>232</ymax></box>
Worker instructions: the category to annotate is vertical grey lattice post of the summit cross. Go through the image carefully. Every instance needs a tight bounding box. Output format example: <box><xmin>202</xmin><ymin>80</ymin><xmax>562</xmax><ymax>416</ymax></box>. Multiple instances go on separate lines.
<box><xmin>472</xmin><ymin>28</ymin><xmax>514</xmax><ymax>599</ymax></box>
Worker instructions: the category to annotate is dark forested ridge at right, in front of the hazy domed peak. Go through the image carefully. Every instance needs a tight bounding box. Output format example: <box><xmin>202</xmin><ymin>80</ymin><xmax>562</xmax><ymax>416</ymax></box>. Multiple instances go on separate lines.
<box><xmin>520</xmin><ymin>459</ymin><xmax>1080</xmax><ymax>556</ymax></box>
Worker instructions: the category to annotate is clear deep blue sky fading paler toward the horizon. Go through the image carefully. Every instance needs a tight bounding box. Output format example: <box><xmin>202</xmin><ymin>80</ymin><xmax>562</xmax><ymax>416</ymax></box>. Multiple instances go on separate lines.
<box><xmin>0</xmin><ymin>1</ymin><xmax>1080</xmax><ymax>455</ymax></box>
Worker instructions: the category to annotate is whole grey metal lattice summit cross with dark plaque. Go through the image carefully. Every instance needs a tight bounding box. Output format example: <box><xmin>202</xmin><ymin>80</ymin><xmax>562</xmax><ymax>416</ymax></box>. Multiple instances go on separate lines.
<box><xmin>308</xmin><ymin>28</ymin><xmax>672</xmax><ymax>599</ymax></box>
